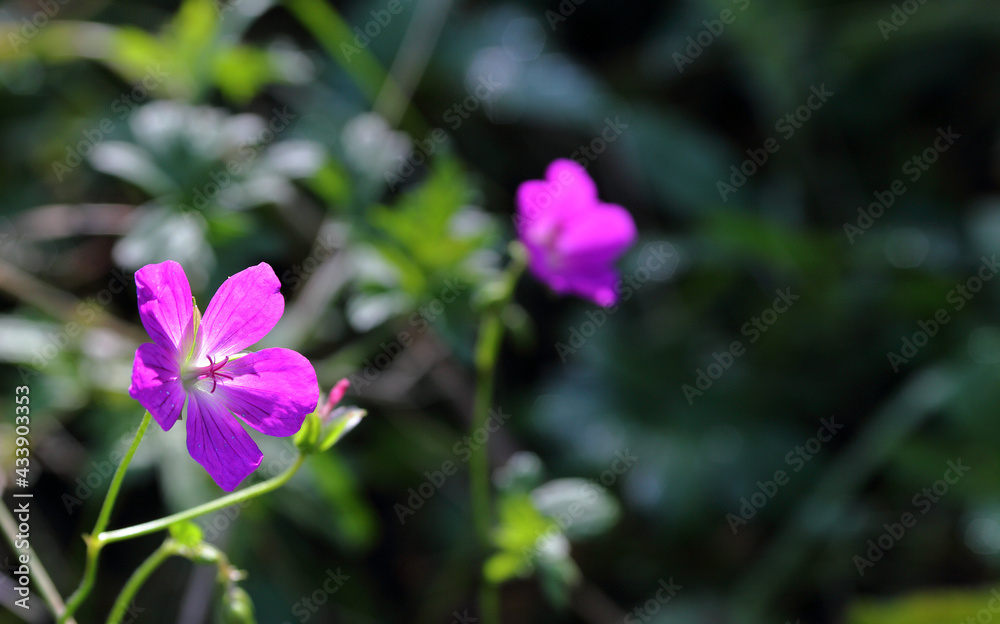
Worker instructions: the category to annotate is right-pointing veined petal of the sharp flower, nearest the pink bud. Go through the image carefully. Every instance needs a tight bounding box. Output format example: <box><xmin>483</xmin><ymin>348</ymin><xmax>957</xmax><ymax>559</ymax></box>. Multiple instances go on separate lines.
<box><xmin>215</xmin><ymin>349</ymin><xmax>319</xmax><ymax>436</ymax></box>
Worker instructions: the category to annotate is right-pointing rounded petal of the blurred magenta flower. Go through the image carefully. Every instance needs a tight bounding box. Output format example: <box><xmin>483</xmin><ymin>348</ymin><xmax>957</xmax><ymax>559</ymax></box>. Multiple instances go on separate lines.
<box><xmin>555</xmin><ymin>204</ymin><xmax>636</xmax><ymax>263</ymax></box>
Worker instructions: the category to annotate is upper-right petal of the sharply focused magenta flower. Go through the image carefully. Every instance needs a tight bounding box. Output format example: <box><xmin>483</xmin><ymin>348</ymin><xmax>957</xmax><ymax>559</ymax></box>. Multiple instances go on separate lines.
<box><xmin>196</xmin><ymin>262</ymin><xmax>285</xmax><ymax>365</ymax></box>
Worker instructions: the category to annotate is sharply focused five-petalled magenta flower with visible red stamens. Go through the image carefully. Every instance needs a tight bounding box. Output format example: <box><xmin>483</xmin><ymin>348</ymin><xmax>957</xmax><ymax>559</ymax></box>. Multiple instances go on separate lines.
<box><xmin>128</xmin><ymin>261</ymin><xmax>319</xmax><ymax>491</ymax></box>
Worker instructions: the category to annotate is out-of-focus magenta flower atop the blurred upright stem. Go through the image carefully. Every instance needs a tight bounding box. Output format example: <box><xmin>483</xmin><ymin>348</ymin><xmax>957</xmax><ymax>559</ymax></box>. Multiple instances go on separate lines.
<box><xmin>516</xmin><ymin>160</ymin><xmax>636</xmax><ymax>306</ymax></box>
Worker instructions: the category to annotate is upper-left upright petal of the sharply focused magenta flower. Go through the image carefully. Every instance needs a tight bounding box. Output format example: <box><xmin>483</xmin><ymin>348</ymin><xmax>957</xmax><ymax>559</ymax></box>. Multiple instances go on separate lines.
<box><xmin>135</xmin><ymin>260</ymin><xmax>194</xmax><ymax>355</ymax></box>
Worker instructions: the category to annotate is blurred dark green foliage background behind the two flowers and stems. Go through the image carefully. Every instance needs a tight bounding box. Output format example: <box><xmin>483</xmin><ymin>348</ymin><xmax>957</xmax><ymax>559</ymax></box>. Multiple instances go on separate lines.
<box><xmin>0</xmin><ymin>0</ymin><xmax>1000</xmax><ymax>624</ymax></box>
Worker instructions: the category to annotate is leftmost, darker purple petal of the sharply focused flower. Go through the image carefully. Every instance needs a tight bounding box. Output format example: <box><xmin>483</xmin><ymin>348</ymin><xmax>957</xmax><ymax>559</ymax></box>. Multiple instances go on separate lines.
<box><xmin>128</xmin><ymin>342</ymin><xmax>186</xmax><ymax>431</ymax></box>
